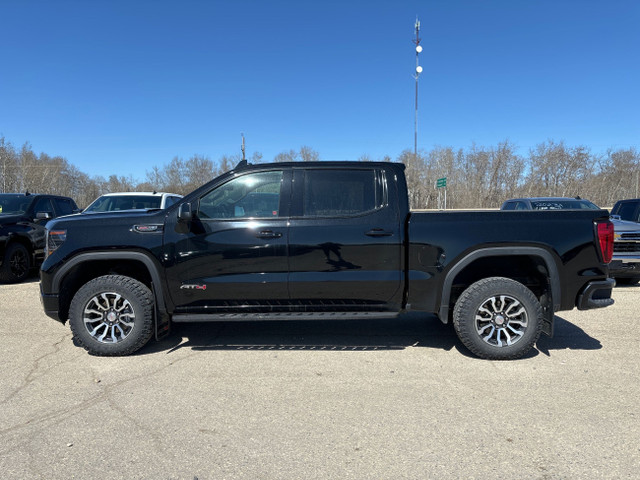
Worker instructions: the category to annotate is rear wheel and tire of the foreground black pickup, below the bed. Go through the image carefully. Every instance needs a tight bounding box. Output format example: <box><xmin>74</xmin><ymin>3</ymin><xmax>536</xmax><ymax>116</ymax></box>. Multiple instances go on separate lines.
<box><xmin>453</xmin><ymin>277</ymin><xmax>542</xmax><ymax>360</ymax></box>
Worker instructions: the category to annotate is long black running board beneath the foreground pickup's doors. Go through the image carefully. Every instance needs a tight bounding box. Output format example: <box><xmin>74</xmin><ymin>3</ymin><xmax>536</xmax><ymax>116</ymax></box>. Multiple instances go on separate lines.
<box><xmin>171</xmin><ymin>312</ymin><xmax>398</xmax><ymax>323</ymax></box>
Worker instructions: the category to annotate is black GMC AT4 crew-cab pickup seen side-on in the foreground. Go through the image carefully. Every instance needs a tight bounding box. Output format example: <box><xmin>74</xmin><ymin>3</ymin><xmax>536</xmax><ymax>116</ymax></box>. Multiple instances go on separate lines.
<box><xmin>40</xmin><ymin>162</ymin><xmax>615</xmax><ymax>359</ymax></box>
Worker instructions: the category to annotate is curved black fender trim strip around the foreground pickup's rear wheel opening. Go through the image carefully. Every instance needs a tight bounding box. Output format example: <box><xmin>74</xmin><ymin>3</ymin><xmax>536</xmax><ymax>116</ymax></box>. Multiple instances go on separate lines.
<box><xmin>438</xmin><ymin>247</ymin><xmax>562</xmax><ymax>323</ymax></box>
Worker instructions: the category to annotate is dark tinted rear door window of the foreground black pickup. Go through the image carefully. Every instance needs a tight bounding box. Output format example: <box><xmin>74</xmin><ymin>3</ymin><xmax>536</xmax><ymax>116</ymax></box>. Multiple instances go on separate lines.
<box><xmin>302</xmin><ymin>169</ymin><xmax>383</xmax><ymax>217</ymax></box>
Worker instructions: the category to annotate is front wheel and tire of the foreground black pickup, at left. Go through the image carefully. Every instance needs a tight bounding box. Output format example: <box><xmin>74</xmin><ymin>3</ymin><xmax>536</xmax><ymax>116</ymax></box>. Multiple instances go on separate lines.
<box><xmin>69</xmin><ymin>275</ymin><xmax>154</xmax><ymax>356</ymax></box>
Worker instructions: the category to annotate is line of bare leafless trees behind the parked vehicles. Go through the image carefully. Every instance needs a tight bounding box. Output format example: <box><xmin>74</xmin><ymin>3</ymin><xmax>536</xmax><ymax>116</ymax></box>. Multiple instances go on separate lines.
<box><xmin>0</xmin><ymin>137</ymin><xmax>640</xmax><ymax>208</ymax></box>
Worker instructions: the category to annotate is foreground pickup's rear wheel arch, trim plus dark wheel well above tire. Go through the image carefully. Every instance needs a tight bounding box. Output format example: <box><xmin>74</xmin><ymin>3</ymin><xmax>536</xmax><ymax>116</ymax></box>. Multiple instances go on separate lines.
<box><xmin>438</xmin><ymin>246</ymin><xmax>562</xmax><ymax>328</ymax></box>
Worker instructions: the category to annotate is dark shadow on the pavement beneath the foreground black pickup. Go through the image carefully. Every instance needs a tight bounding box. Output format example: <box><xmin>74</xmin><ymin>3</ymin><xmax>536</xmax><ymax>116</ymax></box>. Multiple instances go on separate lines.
<box><xmin>144</xmin><ymin>314</ymin><xmax>602</xmax><ymax>358</ymax></box>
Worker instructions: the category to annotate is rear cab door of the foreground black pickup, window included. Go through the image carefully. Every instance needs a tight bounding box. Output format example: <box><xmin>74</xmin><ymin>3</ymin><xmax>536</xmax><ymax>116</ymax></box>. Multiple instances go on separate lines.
<box><xmin>289</xmin><ymin>164</ymin><xmax>402</xmax><ymax>310</ymax></box>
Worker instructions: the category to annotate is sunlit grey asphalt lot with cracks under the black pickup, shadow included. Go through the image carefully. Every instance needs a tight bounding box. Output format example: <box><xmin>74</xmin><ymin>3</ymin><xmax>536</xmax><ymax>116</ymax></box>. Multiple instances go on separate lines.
<box><xmin>0</xmin><ymin>280</ymin><xmax>640</xmax><ymax>480</ymax></box>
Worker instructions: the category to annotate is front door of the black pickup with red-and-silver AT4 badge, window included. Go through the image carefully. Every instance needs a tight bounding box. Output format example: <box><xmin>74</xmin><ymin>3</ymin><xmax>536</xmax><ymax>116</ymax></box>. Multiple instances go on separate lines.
<box><xmin>165</xmin><ymin>169</ymin><xmax>291</xmax><ymax>314</ymax></box>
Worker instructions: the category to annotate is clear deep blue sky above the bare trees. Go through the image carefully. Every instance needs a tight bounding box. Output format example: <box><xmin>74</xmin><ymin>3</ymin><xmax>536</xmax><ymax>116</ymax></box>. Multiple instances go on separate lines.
<box><xmin>0</xmin><ymin>0</ymin><xmax>640</xmax><ymax>180</ymax></box>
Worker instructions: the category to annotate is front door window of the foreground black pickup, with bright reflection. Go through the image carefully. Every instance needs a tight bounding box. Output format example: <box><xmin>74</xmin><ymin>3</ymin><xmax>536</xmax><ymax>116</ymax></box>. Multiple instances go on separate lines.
<box><xmin>198</xmin><ymin>171</ymin><xmax>282</xmax><ymax>219</ymax></box>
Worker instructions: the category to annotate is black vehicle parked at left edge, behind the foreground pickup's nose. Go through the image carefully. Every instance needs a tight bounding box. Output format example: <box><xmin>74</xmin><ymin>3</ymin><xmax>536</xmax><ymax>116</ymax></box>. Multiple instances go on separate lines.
<box><xmin>0</xmin><ymin>192</ymin><xmax>79</xmax><ymax>283</ymax></box>
